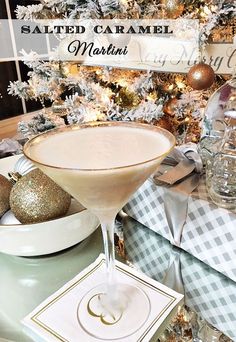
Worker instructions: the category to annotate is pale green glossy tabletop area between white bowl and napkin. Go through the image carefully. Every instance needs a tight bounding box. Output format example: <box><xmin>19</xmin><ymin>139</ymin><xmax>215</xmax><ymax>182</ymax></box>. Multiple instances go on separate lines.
<box><xmin>0</xmin><ymin>229</ymin><xmax>103</xmax><ymax>342</ymax></box>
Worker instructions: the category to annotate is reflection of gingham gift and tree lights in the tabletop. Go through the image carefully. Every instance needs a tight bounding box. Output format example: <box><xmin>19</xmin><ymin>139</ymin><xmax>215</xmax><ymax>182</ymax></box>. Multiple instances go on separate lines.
<box><xmin>123</xmin><ymin>217</ymin><xmax>236</xmax><ymax>342</ymax></box>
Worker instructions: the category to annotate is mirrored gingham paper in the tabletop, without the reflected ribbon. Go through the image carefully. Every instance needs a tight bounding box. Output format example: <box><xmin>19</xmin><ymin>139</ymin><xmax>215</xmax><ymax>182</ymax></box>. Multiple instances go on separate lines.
<box><xmin>124</xmin><ymin>219</ymin><xmax>236</xmax><ymax>341</ymax></box>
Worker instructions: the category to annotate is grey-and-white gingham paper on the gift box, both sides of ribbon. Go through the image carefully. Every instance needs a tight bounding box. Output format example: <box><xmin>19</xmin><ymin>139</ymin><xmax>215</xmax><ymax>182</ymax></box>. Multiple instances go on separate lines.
<box><xmin>124</xmin><ymin>179</ymin><xmax>236</xmax><ymax>281</ymax></box>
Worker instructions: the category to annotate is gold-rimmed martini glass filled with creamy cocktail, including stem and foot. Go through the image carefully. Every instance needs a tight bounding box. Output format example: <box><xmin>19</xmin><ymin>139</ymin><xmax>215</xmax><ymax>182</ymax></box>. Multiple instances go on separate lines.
<box><xmin>24</xmin><ymin>122</ymin><xmax>175</xmax><ymax>340</ymax></box>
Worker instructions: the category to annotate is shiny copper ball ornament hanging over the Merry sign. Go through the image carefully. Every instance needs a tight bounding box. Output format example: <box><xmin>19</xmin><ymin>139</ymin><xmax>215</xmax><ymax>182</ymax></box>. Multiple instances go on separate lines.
<box><xmin>187</xmin><ymin>63</ymin><xmax>215</xmax><ymax>90</ymax></box>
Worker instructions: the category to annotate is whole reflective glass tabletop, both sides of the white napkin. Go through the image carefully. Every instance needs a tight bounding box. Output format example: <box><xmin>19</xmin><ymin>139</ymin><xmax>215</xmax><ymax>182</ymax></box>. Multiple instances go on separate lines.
<box><xmin>0</xmin><ymin>218</ymin><xmax>236</xmax><ymax>342</ymax></box>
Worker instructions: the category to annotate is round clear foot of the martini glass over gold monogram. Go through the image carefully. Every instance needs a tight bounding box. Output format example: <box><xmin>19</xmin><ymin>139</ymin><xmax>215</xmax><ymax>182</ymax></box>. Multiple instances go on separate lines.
<box><xmin>77</xmin><ymin>283</ymin><xmax>151</xmax><ymax>340</ymax></box>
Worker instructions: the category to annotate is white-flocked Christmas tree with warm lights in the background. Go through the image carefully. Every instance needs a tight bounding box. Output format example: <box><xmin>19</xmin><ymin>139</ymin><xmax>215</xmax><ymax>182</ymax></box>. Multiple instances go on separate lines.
<box><xmin>8</xmin><ymin>0</ymin><xmax>236</xmax><ymax>143</ymax></box>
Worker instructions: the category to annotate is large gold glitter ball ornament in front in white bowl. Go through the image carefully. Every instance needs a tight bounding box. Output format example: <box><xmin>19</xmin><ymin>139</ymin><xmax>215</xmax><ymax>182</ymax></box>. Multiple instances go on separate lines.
<box><xmin>10</xmin><ymin>169</ymin><xmax>71</xmax><ymax>224</ymax></box>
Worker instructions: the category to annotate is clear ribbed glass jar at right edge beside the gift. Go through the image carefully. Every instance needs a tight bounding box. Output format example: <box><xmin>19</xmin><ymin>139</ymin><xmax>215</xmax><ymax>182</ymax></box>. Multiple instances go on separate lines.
<box><xmin>206</xmin><ymin>90</ymin><xmax>236</xmax><ymax>211</ymax></box>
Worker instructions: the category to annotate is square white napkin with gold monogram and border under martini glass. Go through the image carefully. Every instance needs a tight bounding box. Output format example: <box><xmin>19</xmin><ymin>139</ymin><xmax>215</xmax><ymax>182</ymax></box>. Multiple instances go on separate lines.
<box><xmin>22</xmin><ymin>254</ymin><xmax>183</xmax><ymax>342</ymax></box>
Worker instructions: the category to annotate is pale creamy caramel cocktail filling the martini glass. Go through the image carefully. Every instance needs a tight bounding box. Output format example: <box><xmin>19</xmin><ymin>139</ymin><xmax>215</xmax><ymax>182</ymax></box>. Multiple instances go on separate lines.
<box><xmin>26</xmin><ymin>125</ymin><xmax>171</xmax><ymax>219</ymax></box>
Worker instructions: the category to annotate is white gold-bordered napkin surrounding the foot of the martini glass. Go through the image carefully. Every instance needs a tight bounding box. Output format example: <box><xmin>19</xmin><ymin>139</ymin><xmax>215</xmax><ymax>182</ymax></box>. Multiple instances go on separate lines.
<box><xmin>23</xmin><ymin>254</ymin><xmax>183</xmax><ymax>342</ymax></box>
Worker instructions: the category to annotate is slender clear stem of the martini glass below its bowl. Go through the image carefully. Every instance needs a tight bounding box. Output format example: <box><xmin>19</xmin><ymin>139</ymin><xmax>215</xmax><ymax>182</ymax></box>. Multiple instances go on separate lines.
<box><xmin>101</xmin><ymin>218</ymin><xmax>117</xmax><ymax>300</ymax></box>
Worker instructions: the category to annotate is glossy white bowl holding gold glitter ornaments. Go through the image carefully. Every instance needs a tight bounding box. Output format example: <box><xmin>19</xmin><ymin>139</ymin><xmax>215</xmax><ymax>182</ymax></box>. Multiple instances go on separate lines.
<box><xmin>0</xmin><ymin>156</ymin><xmax>99</xmax><ymax>256</ymax></box>
